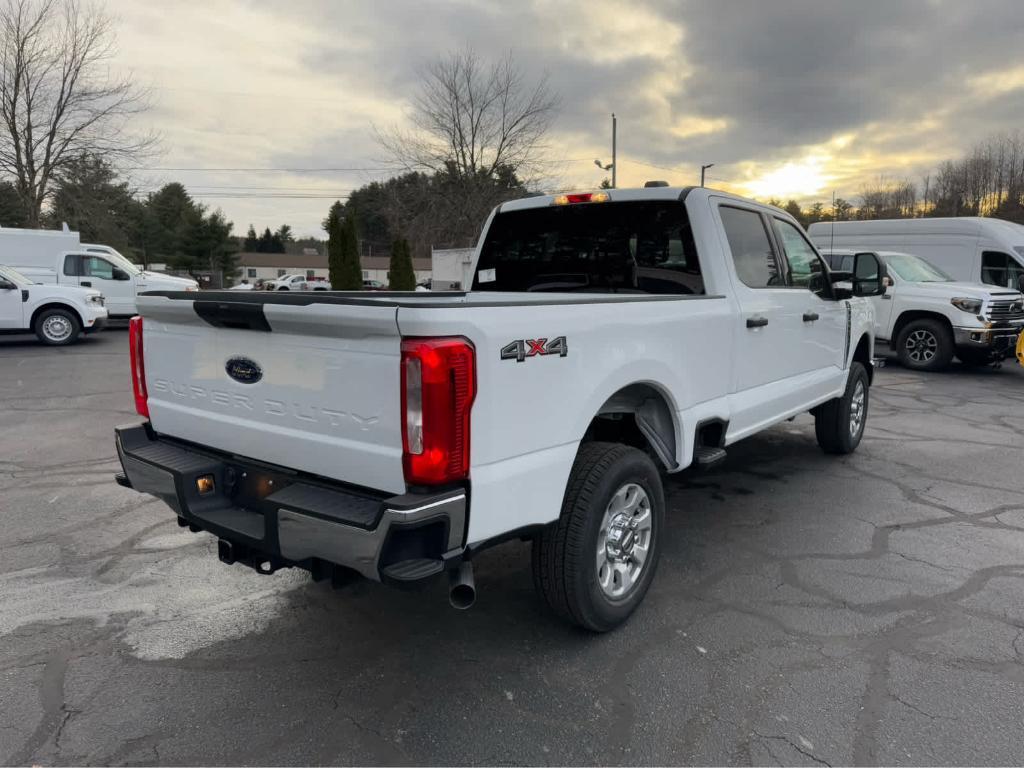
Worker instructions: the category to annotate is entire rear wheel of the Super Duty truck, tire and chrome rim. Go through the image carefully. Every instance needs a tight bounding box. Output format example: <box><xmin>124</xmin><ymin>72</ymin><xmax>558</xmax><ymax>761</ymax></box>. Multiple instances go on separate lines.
<box><xmin>532</xmin><ymin>442</ymin><xmax>665</xmax><ymax>632</ymax></box>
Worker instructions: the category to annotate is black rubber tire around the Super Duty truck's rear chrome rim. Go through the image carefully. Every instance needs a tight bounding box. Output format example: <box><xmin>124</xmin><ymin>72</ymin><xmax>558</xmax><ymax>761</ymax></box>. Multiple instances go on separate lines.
<box><xmin>532</xmin><ymin>442</ymin><xmax>665</xmax><ymax>632</ymax></box>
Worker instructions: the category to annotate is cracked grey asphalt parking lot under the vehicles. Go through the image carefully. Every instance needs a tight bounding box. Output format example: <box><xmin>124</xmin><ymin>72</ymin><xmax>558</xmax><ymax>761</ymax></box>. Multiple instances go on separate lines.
<box><xmin>0</xmin><ymin>330</ymin><xmax>1024</xmax><ymax>765</ymax></box>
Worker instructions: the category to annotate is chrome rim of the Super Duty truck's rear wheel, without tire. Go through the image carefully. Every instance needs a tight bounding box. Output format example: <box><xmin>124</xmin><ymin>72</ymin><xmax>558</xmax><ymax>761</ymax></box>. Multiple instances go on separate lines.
<box><xmin>596</xmin><ymin>482</ymin><xmax>653</xmax><ymax>600</ymax></box>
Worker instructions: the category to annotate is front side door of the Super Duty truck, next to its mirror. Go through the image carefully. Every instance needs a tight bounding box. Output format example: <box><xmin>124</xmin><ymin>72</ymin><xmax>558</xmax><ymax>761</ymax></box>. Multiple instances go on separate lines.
<box><xmin>772</xmin><ymin>216</ymin><xmax>846</xmax><ymax>376</ymax></box>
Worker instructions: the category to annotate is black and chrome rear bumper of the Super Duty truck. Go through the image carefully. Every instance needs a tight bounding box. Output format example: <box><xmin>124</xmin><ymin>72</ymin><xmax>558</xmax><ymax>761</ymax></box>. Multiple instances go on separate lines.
<box><xmin>116</xmin><ymin>423</ymin><xmax>467</xmax><ymax>583</ymax></box>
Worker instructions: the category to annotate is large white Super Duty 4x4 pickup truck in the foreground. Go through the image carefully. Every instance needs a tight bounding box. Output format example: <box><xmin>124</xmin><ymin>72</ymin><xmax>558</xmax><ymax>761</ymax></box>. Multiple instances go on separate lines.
<box><xmin>116</xmin><ymin>187</ymin><xmax>885</xmax><ymax>631</ymax></box>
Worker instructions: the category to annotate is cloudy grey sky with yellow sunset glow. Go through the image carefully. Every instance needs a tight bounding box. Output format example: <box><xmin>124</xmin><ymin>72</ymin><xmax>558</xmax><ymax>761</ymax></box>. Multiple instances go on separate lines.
<box><xmin>109</xmin><ymin>0</ymin><xmax>1024</xmax><ymax>234</ymax></box>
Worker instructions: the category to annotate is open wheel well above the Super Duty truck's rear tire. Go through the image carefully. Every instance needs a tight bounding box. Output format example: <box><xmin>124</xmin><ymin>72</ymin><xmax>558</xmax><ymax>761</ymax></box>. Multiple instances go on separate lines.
<box><xmin>583</xmin><ymin>384</ymin><xmax>679</xmax><ymax>469</ymax></box>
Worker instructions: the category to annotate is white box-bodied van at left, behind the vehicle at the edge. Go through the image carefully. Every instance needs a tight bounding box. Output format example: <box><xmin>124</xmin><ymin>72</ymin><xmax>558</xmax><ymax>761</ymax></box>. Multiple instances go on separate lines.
<box><xmin>0</xmin><ymin>227</ymin><xmax>199</xmax><ymax>318</ymax></box>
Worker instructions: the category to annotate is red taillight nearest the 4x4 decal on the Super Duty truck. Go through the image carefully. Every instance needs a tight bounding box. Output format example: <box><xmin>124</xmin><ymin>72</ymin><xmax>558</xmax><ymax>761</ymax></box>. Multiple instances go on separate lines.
<box><xmin>401</xmin><ymin>337</ymin><xmax>476</xmax><ymax>485</ymax></box>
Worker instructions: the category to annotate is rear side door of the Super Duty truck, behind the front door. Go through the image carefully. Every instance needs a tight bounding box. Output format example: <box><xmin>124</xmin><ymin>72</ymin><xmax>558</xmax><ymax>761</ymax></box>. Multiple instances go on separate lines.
<box><xmin>717</xmin><ymin>200</ymin><xmax>808</xmax><ymax>439</ymax></box>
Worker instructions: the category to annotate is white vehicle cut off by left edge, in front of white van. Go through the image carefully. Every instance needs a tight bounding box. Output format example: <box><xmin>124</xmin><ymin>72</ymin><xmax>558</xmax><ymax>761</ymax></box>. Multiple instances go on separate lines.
<box><xmin>0</xmin><ymin>265</ymin><xmax>106</xmax><ymax>346</ymax></box>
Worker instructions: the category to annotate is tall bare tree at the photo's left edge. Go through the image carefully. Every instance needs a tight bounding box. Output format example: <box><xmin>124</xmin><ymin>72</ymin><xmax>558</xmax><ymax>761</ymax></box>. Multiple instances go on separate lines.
<box><xmin>0</xmin><ymin>0</ymin><xmax>155</xmax><ymax>226</ymax></box>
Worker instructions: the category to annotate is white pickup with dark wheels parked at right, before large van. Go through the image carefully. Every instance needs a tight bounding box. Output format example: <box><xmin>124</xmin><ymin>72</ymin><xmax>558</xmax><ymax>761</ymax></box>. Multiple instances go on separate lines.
<box><xmin>821</xmin><ymin>249</ymin><xmax>1024</xmax><ymax>371</ymax></box>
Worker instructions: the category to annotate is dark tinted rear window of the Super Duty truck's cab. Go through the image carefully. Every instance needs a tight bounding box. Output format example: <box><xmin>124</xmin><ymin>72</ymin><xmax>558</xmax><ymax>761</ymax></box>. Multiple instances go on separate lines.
<box><xmin>473</xmin><ymin>201</ymin><xmax>705</xmax><ymax>294</ymax></box>
